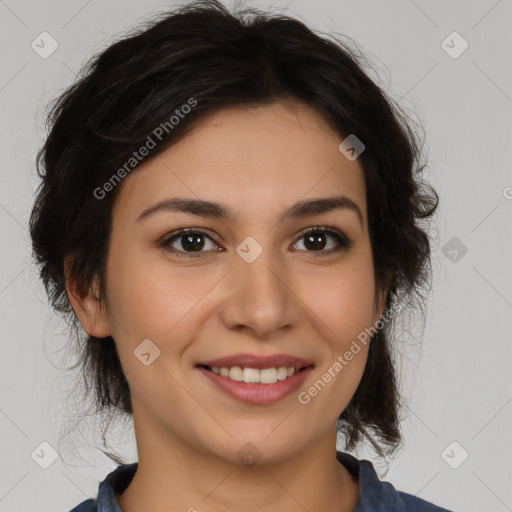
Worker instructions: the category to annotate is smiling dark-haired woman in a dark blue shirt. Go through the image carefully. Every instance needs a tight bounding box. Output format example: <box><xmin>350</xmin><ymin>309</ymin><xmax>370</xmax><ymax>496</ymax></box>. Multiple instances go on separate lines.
<box><xmin>30</xmin><ymin>1</ymin><xmax>452</xmax><ymax>512</ymax></box>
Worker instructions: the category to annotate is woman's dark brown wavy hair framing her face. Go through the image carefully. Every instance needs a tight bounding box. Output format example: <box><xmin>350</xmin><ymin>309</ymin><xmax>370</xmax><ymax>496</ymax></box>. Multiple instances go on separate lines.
<box><xmin>30</xmin><ymin>0</ymin><xmax>439</xmax><ymax>462</ymax></box>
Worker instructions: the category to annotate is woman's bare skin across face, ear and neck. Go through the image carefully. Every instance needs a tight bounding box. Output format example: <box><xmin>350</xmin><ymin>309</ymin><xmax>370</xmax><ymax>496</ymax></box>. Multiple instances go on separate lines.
<box><xmin>68</xmin><ymin>101</ymin><xmax>385</xmax><ymax>512</ymax></box>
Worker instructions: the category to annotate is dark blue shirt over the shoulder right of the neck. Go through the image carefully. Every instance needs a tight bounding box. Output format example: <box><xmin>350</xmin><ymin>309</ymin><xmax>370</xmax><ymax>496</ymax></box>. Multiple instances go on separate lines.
<box><xmin>337</xmin><ymin>452</ymin><xmax>451</xmax><ymax>512</ymax></box>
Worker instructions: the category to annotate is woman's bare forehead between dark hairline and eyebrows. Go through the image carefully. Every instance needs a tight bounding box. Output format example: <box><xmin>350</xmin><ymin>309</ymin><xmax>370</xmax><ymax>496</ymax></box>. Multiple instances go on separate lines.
<box><xmin>114</xmin><ymin>101</ymin><xmax>366</xmax><ymax>226</ymax></box>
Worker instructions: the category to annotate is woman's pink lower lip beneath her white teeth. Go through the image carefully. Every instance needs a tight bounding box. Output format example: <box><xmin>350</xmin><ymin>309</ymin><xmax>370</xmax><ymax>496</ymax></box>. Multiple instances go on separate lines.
<box><xmin>196</xmin><ymin>366</ymin><xmax>313</xmax><ymax>404</ymax></box>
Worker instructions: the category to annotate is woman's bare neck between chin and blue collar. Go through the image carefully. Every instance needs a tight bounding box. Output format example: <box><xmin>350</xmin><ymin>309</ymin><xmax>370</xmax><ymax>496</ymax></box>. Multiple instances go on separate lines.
<box><xmin>116</xmin><ymin>410</ymin><xmax>360</xmax><ymax>512</ymax></box>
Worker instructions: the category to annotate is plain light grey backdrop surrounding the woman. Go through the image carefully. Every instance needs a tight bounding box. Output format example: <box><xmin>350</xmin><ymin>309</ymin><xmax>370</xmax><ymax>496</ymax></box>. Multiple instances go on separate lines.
<box><xmin>0</xmin><ymin>0</ymin><xmax>512</xmax><ymax>512</ymax></box>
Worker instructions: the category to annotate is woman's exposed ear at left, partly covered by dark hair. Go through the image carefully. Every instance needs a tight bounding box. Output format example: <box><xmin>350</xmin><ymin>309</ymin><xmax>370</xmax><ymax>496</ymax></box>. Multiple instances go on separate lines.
<box><xmin>64</xmin><ymin>257</ymin><xmax>110</xmax><ymax>338</ymax></box>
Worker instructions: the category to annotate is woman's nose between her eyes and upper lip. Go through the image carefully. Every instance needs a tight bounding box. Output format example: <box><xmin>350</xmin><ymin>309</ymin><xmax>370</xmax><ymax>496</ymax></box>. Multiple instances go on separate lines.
<box><xmin>221</xmin><ymin>251</ymin><xmax>301</xmax><ymax>338</ymax></box>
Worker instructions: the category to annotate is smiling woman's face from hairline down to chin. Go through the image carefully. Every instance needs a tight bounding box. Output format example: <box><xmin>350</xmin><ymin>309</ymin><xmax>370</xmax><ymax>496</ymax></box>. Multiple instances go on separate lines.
<box><xmin>73</xmin><ymin>102</ymin><xmax>384</xmax><ymax>463</ymax></box>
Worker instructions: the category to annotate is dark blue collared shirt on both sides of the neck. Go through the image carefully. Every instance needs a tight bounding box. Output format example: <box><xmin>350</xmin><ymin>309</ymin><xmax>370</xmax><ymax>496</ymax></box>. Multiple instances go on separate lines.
<box><xmin>70</xmin><ymin>452</ymin><xmax>451</xmax><ymax>512</ymax></box>
